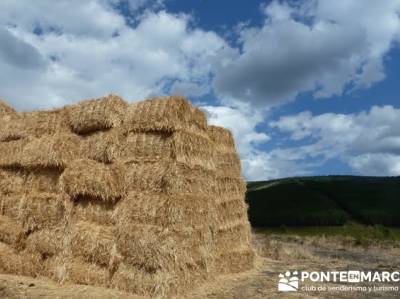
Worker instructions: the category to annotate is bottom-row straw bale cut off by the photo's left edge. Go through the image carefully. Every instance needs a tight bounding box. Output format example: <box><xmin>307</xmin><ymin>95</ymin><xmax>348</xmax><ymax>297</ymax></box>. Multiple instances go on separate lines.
<box><xmin>0</xmin><ymin>242</ymin><xmax>41</xmax><ymax>277</ymax></box>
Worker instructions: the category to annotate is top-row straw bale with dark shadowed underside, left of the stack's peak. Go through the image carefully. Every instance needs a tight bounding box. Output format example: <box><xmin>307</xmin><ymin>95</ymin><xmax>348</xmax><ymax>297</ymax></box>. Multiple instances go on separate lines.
<box><xmin>67</xmin><ymin>95</ymin><xmax>128</xmax><ymax>134</ymax></box>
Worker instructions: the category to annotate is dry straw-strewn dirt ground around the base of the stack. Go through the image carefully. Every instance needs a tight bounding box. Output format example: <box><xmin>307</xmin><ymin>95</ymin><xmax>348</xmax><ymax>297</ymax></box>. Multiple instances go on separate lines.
<box><xmin>0</xmin><ymin>234</ymin><xmax>400</xmax><ymax>299</ymax></box>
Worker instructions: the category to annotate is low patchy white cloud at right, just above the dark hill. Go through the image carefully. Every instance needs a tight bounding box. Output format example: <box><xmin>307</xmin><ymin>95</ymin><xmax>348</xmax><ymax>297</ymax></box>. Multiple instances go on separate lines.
<box><xmin>270</xmin><ymin>106</ymin><xmax>400</xmax><ymax>175</ymax></box>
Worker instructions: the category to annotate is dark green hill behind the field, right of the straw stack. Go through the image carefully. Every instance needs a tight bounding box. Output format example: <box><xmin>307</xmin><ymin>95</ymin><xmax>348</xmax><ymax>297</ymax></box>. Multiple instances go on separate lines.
<box><xmin>246</xmin><ymin>176</ymin><xmax>400</xmax><ymax>227</ymax></box>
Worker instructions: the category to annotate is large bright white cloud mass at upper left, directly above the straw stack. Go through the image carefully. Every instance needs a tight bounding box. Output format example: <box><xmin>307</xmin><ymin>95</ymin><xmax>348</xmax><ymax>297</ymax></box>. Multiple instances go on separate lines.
<box><xmin>0</xmin><ymin>0</ymin><xmax>230</xmax><ymax>110</ymax></box>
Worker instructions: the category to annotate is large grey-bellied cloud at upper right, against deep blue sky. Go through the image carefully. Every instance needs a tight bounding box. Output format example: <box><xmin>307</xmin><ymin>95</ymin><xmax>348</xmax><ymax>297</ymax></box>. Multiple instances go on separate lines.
<box><xmin>214</xmin><ymin>0</ymin><xmax>400</xmax><ymax>106</ymax></box>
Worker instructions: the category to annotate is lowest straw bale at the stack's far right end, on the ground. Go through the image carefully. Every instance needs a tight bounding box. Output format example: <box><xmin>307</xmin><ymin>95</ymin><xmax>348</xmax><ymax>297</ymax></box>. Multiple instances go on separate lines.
<box><xmin>216</xmin><ymin>246</ymin><xmax>255</xmax><ymax>274</ymax></box>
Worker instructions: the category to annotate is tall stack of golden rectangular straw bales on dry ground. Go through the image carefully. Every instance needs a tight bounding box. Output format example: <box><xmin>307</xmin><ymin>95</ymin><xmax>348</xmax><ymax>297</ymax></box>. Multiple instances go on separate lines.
<box><xmin>0</xmin><ymin>95</ymin><xmax>254</xmax><ymax>297</ymax></box>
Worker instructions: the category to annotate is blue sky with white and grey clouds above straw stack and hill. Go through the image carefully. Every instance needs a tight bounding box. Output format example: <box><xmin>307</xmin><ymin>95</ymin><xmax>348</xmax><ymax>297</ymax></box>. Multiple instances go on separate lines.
<box><xmin>0</xmin><ymin>0</ymin><xmax>400</xmax><ymax>180</ymax></box>
